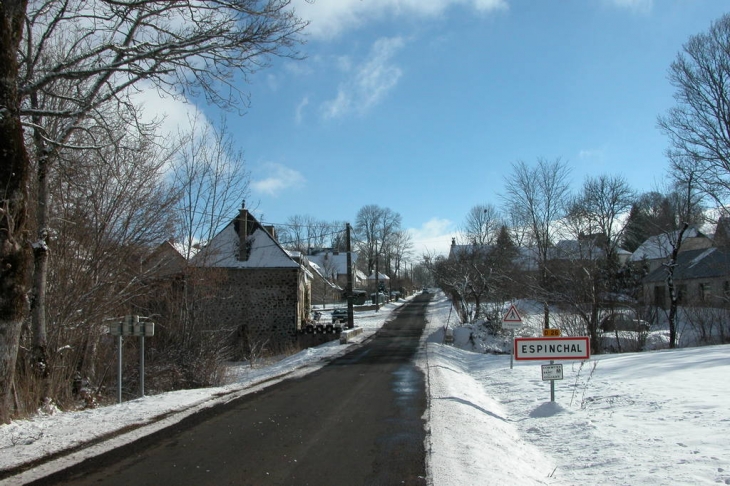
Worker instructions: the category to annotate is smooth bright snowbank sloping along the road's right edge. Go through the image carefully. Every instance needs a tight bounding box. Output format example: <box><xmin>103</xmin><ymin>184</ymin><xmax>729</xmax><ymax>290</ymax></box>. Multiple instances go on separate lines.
<box><xmin>418</xmin><ymin>343</ymin><xmax>555</xmax><ymax>486</ymax></box>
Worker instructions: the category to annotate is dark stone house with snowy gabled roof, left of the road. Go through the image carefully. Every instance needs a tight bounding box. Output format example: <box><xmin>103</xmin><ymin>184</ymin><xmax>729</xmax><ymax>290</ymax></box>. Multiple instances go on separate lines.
<box><xmin>190</xmin><ymin>208</ymin><xmax>313</xmax><ymax>356</ymax></box>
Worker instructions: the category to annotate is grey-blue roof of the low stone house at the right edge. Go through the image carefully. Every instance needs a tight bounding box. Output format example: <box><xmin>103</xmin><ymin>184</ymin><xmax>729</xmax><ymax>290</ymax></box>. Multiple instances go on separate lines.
<box><xmin>643</xmin><ymin>247</ymin><xmax>730</xmax><ymax>283</ymax></box>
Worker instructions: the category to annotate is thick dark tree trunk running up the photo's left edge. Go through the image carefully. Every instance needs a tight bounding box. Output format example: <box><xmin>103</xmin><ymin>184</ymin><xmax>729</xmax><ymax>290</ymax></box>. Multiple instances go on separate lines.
<box><xmin>0</xmin><ymin>0</ymin><xmax>31</xmax><ymax>423</ymax></box>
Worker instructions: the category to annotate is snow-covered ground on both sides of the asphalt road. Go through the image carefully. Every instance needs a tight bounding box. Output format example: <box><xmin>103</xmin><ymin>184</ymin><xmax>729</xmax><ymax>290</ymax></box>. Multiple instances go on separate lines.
<box><xmin>0</xmin><ymin>293</ymin><xmax>730</xmax><ymax>486</ymax></box>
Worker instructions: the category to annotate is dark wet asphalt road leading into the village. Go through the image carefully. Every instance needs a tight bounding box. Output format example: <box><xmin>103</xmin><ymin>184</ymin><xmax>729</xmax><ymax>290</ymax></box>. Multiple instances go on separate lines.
<box><xmin>32</xmin><ymin>296</ymin><xmax>429</xmax><ymax>486</ymax></box>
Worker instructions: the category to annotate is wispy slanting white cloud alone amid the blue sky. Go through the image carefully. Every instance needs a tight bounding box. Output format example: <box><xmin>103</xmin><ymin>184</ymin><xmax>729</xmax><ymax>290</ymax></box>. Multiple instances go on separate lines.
<box><xmin>322</xmin><ymin>37</ymin><xmax>405</xmax><ymax>118</ymax></box>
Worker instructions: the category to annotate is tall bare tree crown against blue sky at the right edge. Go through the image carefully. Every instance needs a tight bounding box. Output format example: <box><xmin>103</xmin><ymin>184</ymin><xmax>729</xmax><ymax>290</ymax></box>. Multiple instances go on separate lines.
<box><xmin>659</xmin><ymin>14</ymin><xmax>730</xmax><ymax>206</ymax></box>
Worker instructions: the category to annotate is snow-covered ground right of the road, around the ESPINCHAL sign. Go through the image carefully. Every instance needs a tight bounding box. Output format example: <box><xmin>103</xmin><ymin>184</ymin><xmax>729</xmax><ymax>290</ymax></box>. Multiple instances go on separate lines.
<box><xmin>424</xmin><ymin>294</ymin><xmax>730</xmax><ymax>486</ymax></box>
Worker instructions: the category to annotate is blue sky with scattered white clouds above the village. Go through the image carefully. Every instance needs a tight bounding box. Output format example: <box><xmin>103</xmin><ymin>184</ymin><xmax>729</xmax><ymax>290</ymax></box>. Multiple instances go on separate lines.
<box><xmin>193</xmin><ymin>0</ymin><xmax>730</xmax><ymax>256</ymax></box>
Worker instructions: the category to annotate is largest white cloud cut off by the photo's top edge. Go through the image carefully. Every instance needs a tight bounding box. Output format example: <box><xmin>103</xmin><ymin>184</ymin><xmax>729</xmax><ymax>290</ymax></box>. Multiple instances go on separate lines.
<box><xmin>292</xmin><ymin>0</ymin><xmax>508</xmax><ymax>39</ymax></box>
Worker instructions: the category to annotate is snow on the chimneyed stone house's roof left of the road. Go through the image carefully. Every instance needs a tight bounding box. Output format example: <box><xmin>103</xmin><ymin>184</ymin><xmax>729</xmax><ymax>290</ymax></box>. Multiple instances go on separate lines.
<box><xmin>191</xmin><ymin>223</ymin><xmax>299</xmax><ymax>268</ymax></box>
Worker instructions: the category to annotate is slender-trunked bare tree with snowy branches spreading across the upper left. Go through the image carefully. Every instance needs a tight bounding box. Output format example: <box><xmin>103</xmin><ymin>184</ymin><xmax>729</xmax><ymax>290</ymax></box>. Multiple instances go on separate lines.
<box><xmin>7</xmin><ymin>0</ymin><xmax>305</xmax><ymax>418</ymax></box>
